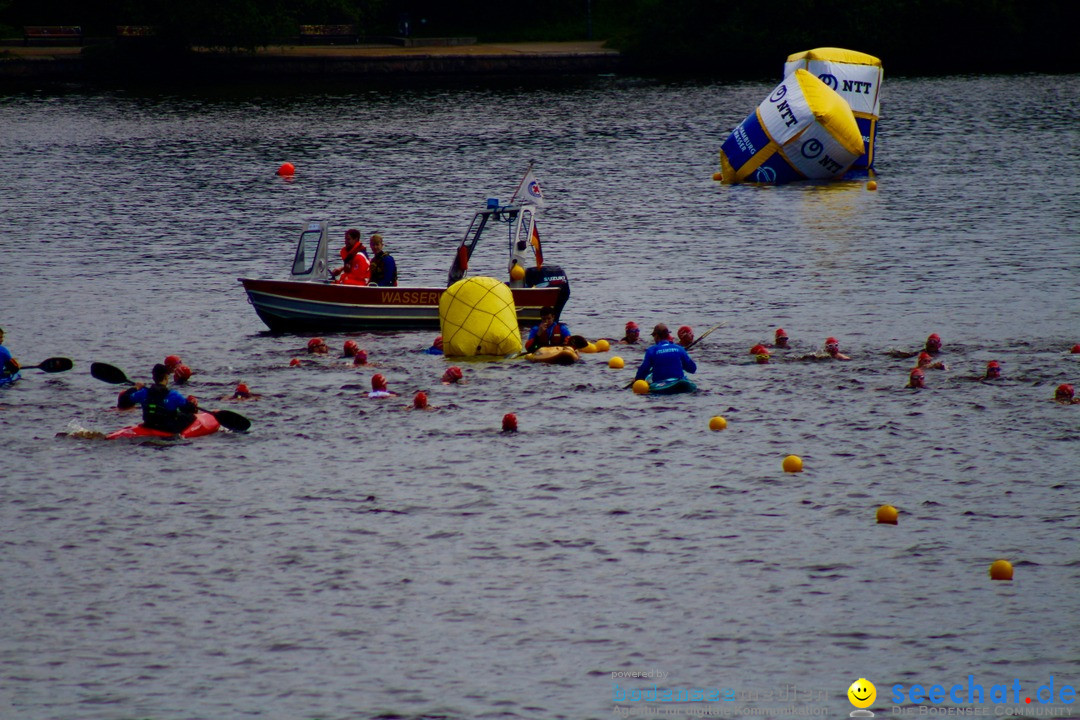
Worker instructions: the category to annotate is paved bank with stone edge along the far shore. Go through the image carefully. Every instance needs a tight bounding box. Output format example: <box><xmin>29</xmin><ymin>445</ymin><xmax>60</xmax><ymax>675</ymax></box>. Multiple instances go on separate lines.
<box><xmin>0</xmin><ymin>41</ymin><xmax>621</xmax><ymax>82</ymax></box>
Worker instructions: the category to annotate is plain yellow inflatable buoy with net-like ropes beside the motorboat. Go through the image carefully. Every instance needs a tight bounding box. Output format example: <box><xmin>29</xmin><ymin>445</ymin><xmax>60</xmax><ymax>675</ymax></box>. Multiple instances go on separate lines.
<box><xmin>438</xmin><ymin>277</ymin><xmax>522</xmax><ymax>357</ymax></box>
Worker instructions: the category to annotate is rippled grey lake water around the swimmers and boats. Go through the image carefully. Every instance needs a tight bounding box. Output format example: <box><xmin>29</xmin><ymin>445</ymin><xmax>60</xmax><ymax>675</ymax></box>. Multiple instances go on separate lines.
<box><xmin>0</xmin><ymin>76</ymin><xmax>1080</xmax><ymax>720</ymax></box>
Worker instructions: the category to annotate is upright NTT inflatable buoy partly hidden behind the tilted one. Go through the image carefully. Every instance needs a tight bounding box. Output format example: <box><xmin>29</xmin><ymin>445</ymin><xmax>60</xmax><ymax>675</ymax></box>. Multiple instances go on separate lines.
<box><xmin>784</xmin><ymin>47</ymin><xmax>885</xmax><ymax>169</ymax></box>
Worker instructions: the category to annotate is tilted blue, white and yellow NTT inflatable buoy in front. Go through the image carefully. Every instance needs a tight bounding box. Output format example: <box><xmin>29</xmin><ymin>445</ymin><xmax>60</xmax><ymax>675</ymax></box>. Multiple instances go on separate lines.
<box><xmin>720</xmin><ymin>69</ymin><xmax>863</xmax><ymax>185</ymax></box>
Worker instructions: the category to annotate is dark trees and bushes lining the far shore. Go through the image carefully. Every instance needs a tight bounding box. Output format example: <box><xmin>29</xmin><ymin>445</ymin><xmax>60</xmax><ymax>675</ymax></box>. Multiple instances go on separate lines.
<box><xmin>0</xmin><ymin>0</ymin><xmax>1080</xmax><ymax>77</ymax></box>
